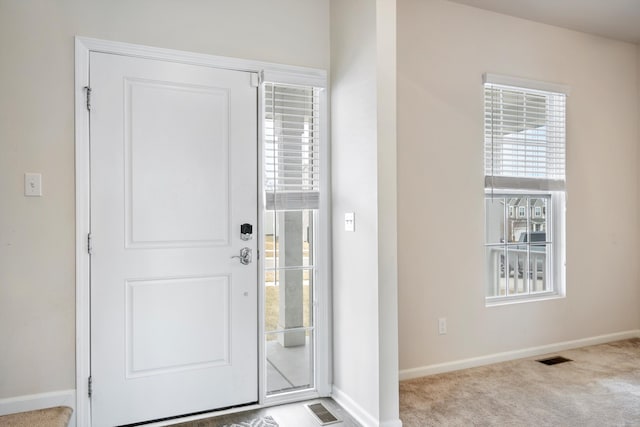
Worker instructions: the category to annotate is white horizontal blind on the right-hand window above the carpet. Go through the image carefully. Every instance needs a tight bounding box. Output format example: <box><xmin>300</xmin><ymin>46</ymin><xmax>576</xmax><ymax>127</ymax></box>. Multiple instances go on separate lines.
<box><xmin>484</xmin><ymin>83</ymin><xmax>566</xmax><ymax>191</ymax></box>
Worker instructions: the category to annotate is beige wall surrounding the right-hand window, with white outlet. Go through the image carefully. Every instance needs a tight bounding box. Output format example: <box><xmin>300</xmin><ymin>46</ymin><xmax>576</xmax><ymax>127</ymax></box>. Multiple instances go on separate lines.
<box><xmin>397</xmin><ymin>0</ymin><xmax>640</xmax><ymax>370</ymax></box>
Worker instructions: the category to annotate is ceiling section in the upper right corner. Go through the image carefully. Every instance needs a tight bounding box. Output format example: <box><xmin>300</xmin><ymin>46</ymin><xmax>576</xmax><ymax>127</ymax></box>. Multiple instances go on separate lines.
<box><xmin>450</xmin><ymin>0</ymin><xmax>640</xmax><ymax>44</ymax></box>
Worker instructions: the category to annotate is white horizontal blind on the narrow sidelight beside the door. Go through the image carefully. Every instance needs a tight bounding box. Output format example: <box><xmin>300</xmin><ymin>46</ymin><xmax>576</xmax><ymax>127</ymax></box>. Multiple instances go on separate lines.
<box><xmin>263</xmin><ymin>83</ymin><xmax>320</xmax><ymax>210</ymax></box>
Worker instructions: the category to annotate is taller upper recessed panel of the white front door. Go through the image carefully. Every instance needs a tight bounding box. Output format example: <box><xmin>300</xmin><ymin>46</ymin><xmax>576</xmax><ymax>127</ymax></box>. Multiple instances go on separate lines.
<box><xmin>124</xmin><ymin>80</ymin><xmax>230</xmax><ymax>247</ymax></box>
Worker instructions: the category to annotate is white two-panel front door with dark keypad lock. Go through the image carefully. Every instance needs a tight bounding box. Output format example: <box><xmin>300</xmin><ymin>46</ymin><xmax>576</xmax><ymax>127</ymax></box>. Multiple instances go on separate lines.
<box><xmin>90</xmin><ymin>52</ymin><xmax>258</xmax><ymax>426</ymax></box>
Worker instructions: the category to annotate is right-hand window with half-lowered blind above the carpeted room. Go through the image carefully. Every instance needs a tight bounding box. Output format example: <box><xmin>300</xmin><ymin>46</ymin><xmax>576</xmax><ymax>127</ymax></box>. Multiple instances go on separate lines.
<box><xmin>484</xmin><ymin>75</ymin><xmax>567</xmax><ymax>304</ymax></box>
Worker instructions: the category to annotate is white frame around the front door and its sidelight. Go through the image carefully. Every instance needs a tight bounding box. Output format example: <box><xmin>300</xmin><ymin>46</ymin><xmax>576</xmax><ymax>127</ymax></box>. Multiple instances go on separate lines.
<box><xmin>74</xmin><ymin>36</ymin><xmax>332</xmax><ymax>427</ymax></box>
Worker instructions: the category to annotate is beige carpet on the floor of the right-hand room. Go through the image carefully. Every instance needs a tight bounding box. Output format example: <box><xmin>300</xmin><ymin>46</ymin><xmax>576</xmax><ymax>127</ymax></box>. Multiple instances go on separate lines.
<box><xmin>400</xmin><ymin>339</ymin><xmax>640</xmax><ymax>427</ymax></box>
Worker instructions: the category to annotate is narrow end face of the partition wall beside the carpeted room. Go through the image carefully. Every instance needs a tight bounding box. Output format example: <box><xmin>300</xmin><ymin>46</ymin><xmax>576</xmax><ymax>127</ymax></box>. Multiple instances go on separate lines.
<box><xmin>376</xmin><ymin>0</ymin><xmax>400</xmax><ymax>427</ymax></box>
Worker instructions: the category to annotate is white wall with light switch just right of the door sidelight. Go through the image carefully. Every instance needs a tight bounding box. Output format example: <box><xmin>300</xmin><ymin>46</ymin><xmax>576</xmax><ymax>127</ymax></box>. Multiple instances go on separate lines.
<box><xmin>330</xmin><ymin>0</ymin><xmax>379</xmax><ymax>418</ymax></box>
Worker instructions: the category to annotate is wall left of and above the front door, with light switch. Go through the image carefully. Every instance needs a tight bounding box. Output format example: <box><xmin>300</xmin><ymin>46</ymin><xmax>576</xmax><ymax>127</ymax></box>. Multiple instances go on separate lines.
<box><xmin>0</xmin><ymin>0</ymin><xmax>329</xmax><ymax>398</ymax></box>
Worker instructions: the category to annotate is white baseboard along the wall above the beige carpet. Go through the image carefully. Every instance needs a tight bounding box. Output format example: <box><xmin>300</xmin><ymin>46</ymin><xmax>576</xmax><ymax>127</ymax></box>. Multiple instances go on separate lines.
<box><xmin>399</xmin><ymin>330</ymin><xmax>640</xmax><ymax>381</ymax></box>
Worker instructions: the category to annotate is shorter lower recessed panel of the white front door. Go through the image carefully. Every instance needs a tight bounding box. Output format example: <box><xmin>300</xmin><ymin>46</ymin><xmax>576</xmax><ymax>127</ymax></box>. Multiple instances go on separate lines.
<box><xmin>126</xmin><ymin>276</ymin><xmax>230</xmax><ymax>378</ymax></box>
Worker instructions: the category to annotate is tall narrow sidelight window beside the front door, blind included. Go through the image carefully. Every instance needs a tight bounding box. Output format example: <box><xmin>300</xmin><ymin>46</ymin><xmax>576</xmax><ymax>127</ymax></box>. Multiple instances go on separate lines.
<box><xmin>262</xmin><ymin>83</ymin><xmax>321</xmax><ymax>396</ymax></box>
